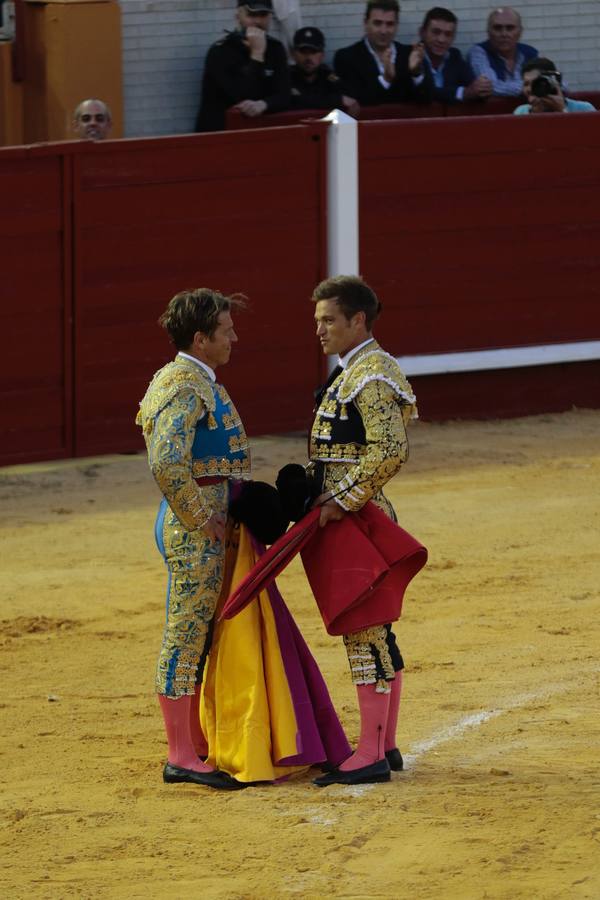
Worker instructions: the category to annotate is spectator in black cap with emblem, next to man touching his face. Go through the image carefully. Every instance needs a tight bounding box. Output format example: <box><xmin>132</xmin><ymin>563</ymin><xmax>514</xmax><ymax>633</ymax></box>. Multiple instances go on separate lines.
<box><xmin>290</xmin><ymin>27</ymin><xmax>359</xmax><ymax>115</ymax></box>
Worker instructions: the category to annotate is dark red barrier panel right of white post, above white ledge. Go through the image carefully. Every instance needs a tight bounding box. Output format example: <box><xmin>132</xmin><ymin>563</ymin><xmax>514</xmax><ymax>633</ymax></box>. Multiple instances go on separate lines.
<box><xmin>359</xmin><ymin>114</ymin><xmax>600</xmax><ymax>355</ymax></box>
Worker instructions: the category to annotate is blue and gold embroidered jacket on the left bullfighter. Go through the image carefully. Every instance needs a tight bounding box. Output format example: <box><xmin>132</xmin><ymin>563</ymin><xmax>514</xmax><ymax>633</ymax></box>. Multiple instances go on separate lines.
<box><xmin>136</xmin><ymin>355</ymin><xmax>250</xmax><ymax>530</ymax></box>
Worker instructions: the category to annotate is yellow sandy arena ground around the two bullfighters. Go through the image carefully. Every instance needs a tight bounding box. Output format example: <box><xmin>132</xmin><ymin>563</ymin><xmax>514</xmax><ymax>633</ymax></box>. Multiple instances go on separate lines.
<box><xmin>0</xmin><ymin>411</ymin><xmax>600</xmax><ymax>900</ymax></box>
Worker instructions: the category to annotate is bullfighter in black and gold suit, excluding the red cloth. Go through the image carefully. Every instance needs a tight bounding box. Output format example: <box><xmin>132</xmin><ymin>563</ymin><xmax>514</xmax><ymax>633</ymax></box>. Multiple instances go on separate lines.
<box><xmin>309</xmin><ymin>276</ymin><xmax>417</xmax><ymax>786</ymax></box>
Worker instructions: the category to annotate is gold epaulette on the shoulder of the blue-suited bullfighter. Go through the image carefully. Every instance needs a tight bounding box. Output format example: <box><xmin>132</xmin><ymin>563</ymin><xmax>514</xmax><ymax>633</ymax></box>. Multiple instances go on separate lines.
<box><xmin>135</xmin><ymin>359</ymin><xmax>216</xmax><ymax>434</ymax></box>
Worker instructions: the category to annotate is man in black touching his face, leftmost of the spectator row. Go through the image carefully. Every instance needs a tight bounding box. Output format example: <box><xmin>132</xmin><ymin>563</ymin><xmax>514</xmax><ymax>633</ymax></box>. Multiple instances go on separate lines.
<box><xmin>196</xmin><ymin>0</ymin><xmax>290</xmax><ymax>131</ymax></box>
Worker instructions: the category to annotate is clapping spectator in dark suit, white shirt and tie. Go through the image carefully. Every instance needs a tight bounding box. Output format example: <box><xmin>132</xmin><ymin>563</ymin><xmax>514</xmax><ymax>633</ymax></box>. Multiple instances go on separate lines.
<box><xmin>333</xmin><ymin>0</ymin><xmax>425</xmax><ymax>106</ymax></box>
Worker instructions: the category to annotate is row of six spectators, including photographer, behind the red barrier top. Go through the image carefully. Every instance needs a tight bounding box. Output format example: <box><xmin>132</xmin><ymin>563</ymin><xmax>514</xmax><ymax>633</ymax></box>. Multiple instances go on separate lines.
<box><xmin>196</xmin><ymin>0</ymin><xmax>595</xmax><ymax>137</ymax></box>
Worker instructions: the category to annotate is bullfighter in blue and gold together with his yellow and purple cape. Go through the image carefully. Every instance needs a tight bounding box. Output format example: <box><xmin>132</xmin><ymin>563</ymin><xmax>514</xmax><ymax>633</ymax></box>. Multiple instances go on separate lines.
<box><xmin>137</xmin><ymin>288</ymin><xmax>350</xmax><ymax>790</ymax></box>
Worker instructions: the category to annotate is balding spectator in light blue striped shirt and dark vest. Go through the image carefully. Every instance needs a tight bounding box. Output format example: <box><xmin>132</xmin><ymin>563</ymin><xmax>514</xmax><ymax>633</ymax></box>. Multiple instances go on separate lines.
<box><xmin>467</xmin><ymin>6</ymin><xmax>538</xmax><ymax>97</ymax></box>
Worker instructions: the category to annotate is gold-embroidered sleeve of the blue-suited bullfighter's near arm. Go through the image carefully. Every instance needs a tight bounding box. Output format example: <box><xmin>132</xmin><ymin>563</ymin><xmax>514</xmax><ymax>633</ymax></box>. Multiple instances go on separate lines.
<box><xmin>147</xmin><ymin>390</ymin><xmax>212</xmax><ymax>531</ymax></box>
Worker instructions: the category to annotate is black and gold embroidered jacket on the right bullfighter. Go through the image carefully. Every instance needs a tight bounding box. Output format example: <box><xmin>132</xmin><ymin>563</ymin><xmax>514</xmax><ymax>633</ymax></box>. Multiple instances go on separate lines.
<box><xmin>310</xmin><ymin>340</ymin><xmax>417</xmax><ymax>517</ymax></box>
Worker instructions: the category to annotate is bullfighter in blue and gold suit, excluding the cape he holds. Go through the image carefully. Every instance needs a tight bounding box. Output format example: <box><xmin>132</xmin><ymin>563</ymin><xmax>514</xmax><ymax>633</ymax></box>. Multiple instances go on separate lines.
<box><xmin>136</xmin><ymin>288</ymin><xmax>250</xmax><ymax>790</ymax></box>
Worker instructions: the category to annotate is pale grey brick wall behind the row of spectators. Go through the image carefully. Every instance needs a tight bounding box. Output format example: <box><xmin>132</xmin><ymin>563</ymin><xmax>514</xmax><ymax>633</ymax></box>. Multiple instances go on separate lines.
<box><xmin>121</xmin><ymin>0</ymin><xmax>600</xmax><ymax>136</ymax></box>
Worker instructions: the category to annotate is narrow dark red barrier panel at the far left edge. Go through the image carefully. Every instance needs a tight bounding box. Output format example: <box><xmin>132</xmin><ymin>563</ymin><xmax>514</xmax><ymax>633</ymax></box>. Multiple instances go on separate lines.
<box><xmin>0</xmin><ymin>152</ymin><xmax>72</xmax><ymax>464</ymax></box>
